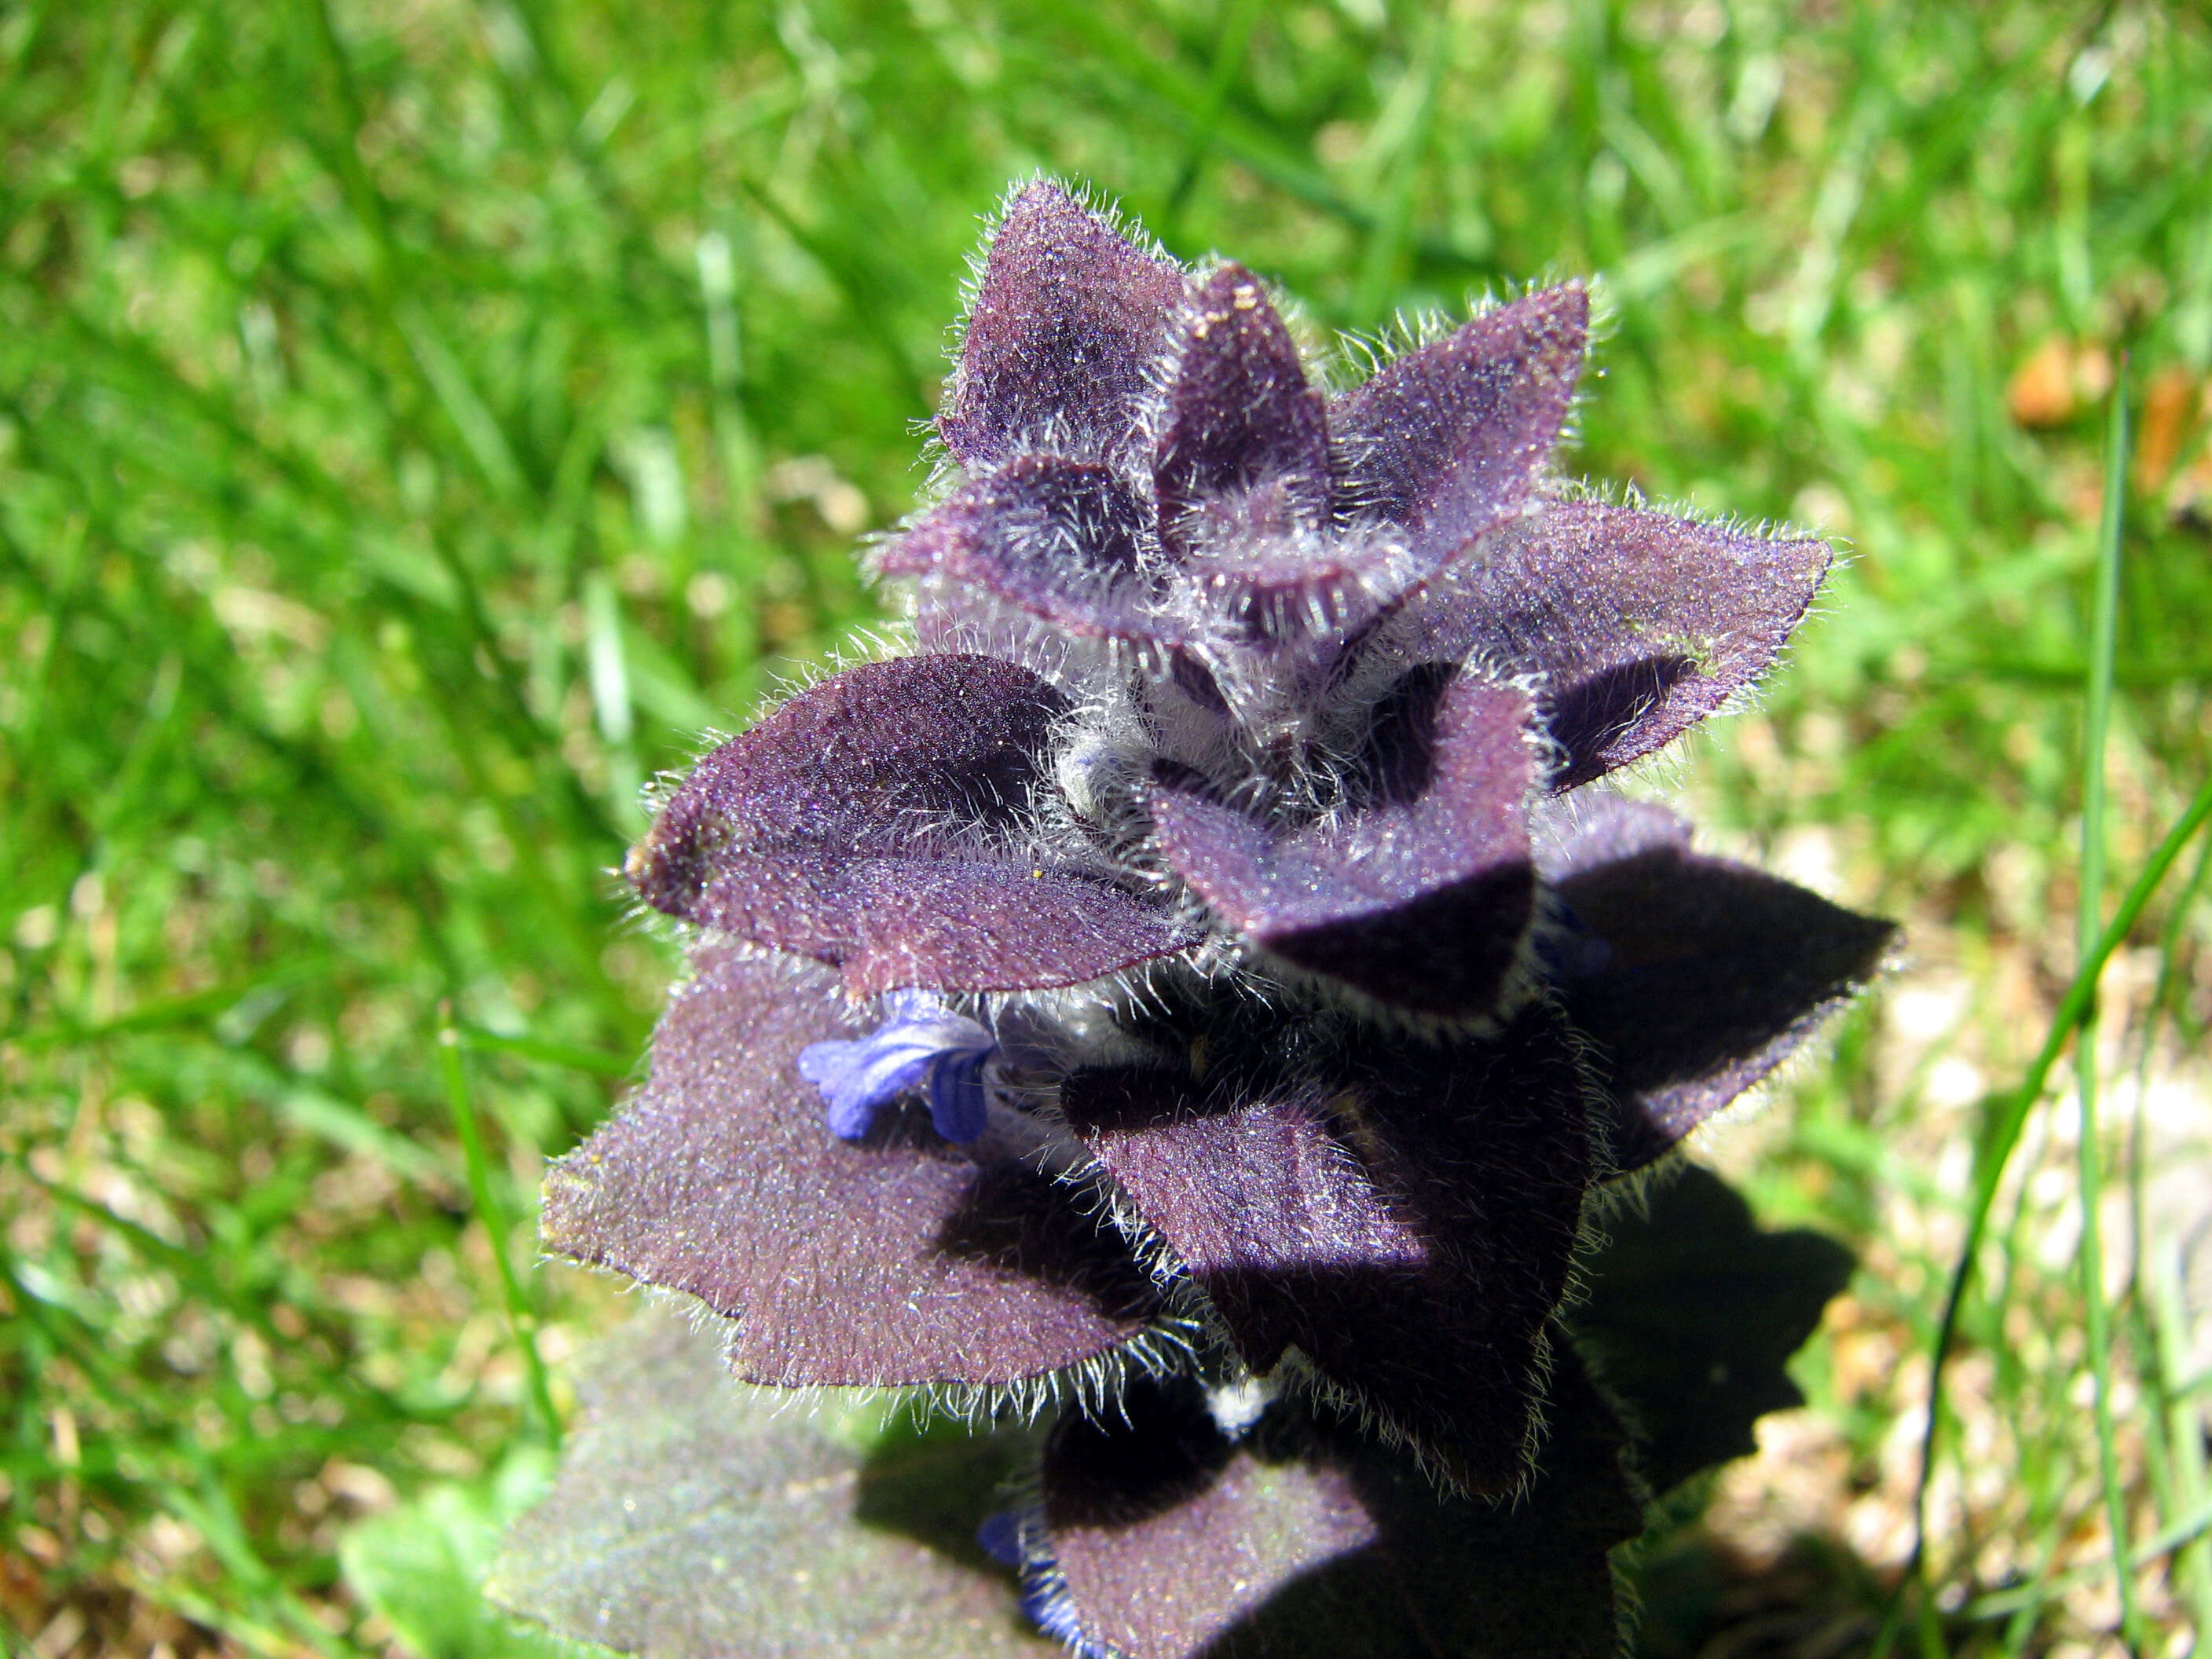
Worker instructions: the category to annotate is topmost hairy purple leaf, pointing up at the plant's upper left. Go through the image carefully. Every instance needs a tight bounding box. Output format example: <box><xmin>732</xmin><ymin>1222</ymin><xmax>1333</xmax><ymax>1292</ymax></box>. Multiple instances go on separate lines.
<box><xmin>938</xmin><ymin>181</ymin><xmax>1190</xmax><ymax>471</ymax></box>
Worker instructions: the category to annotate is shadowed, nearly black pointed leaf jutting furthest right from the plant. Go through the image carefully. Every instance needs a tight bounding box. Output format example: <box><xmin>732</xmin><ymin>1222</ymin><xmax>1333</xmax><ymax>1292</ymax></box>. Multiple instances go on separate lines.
<box><xmin>1540</xmin><ymin>789</ymin><xmax>1895</xmax><ymax>1170</ymax></box>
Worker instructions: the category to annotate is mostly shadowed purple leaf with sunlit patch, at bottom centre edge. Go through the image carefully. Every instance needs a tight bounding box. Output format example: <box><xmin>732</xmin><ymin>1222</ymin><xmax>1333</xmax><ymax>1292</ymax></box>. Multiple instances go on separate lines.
<box><xmin>1040</xmin><ymin>1352</ymin><xmax>1643</xmax><ymax>1659</ymax></box>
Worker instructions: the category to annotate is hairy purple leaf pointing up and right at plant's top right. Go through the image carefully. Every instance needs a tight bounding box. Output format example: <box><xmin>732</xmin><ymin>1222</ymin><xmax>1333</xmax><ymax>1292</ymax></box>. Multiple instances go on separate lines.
<box><xmin>1329</xmin><ymin>283</ymin><xmax>1591</xmax><ymax>569</ymax></box>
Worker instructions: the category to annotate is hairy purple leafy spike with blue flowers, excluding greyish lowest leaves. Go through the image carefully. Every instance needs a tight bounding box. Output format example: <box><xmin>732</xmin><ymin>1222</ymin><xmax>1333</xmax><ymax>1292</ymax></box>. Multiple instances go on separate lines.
<box><xmin>506</xmin><ymin>181</ymin><xmax>1892</xmax><ymax>1659</ymax></box>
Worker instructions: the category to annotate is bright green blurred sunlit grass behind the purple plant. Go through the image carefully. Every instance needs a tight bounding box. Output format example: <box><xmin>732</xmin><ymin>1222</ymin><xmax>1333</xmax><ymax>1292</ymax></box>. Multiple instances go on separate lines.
<box><xmin>0</xmin><ymin>0</ymin><xmax>2212</xmax><ymax>1659</ymax></box>
